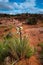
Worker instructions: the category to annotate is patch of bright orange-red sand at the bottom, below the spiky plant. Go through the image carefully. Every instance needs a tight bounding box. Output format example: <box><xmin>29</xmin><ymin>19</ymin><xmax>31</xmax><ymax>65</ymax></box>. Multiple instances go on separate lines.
<box><xmin>15</xmin><ymin>56</ymin><xmax>41</xmax><ymax>65</ymax></box>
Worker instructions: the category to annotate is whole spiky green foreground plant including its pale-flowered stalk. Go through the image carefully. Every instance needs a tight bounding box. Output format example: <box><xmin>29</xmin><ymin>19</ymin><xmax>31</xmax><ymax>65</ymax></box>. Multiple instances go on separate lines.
<box><xmin>2</xmin><ymin>27</ymin><xmax>34</xmax><ymax>64</ymax></box>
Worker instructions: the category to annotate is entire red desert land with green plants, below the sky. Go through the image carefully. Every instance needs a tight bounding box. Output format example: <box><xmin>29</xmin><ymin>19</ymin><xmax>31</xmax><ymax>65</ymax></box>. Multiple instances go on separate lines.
<box><xmin>0</xmin><ymin>13</ymin><xmax>43</xmax><ymax>65</ymax></box>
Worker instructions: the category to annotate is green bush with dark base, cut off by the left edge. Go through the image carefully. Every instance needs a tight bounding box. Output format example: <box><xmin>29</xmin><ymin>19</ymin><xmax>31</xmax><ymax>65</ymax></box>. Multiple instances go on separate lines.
<box><xmin>0</xmin><ymin>41</ymin><xmax>9</xmax><ymax>62</ymax></box>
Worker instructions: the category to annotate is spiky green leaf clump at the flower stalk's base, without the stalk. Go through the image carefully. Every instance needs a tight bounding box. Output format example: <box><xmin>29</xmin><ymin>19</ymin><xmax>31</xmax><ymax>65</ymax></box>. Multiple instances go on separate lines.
<box><xmin>9</xmin><ymin>37</ymin><xmax>34</xmax><ymax>59</ymax></box>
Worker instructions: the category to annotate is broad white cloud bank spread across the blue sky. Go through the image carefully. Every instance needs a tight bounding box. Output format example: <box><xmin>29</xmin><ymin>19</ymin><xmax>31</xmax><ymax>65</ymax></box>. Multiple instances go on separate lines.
<box><xmin>0</xmin><ymin>0</ymin><xmax>43</xmax><ymax>14</ymax></box>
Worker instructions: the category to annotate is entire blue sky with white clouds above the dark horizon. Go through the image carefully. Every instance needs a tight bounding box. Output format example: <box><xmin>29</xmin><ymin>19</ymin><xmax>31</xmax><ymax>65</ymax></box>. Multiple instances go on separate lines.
<box><xmin>0</xmin><ymin>0</ymin><xmax>43</xmax><ymax>14</ymax></box>
